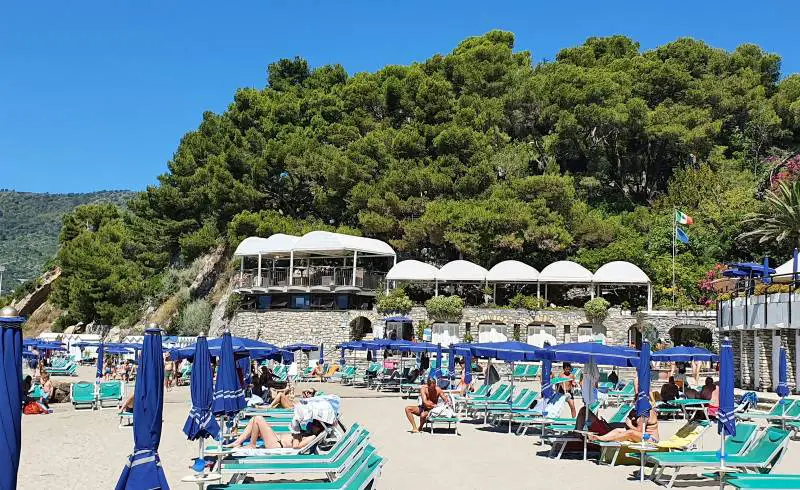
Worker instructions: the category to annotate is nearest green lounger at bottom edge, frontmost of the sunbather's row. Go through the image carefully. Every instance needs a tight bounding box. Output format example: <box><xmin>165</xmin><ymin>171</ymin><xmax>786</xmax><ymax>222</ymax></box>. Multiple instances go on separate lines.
<box><xmin>207</xmin><ymin>451</ymin><xmax>385</xmax><ymax>490</ymax></box>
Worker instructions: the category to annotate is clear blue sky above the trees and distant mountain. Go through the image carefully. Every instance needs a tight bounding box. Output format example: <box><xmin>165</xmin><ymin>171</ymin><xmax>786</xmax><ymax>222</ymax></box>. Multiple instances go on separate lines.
<box><xmin>0</xmin><ymin>0</ymin><xmax>800</xmax><ymax>192</ymax></box>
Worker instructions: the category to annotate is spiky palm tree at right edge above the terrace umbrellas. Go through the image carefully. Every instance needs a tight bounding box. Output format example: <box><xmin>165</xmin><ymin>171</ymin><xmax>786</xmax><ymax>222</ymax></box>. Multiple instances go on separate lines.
<box><xmin>739</xmin><ymin>180</ymin><xmax>800</xmax><ymax>247</ymax></box>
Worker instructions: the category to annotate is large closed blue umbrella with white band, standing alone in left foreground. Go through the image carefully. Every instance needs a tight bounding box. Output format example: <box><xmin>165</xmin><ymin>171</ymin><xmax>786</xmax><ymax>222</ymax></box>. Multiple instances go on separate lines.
<box><xmin>116</xmin><ymin>328</ymin><xmax>169</xmax><ymax>490</ymax></box>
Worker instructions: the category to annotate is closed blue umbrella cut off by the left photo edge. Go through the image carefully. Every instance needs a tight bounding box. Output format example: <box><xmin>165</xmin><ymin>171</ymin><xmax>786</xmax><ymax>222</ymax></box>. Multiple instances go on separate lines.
<box><xmin>0</xmin><ymin>308</ymin><xmax>25</xmax><ymax>490</ymax></box>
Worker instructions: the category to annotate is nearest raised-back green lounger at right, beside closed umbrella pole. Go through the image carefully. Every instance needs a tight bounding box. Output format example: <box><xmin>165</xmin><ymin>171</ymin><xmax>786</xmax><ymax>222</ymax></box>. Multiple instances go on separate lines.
<box><xmin>645</xmin><ymin>424</ymin><xmax>789</xmax><ymax>488</ymax></box>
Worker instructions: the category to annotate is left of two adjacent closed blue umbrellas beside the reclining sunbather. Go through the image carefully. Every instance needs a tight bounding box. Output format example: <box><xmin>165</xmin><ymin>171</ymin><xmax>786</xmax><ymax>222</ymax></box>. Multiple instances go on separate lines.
<box><xmin>183</xmin><ymin>336</ymin><xmax>219</xmax><ymax>441</ymax></box>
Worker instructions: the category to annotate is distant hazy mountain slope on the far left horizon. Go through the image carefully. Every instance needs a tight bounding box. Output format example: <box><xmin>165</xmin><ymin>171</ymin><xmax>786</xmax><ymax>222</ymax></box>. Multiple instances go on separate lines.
<box><xmin>0</xmin><ymin>189</ymin><xmax>134</xmax><ymax>292</ymax></box>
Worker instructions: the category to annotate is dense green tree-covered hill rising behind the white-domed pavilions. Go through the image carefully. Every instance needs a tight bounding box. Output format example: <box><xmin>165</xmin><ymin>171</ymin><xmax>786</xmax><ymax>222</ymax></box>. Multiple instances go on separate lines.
<box><xmin>43</xmin><ymin>31</ymin><xmax>800</xmax><ymax>330</ymax></box>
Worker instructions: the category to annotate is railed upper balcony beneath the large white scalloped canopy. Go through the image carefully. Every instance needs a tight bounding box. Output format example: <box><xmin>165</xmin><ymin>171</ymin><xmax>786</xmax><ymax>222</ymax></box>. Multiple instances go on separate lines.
<box><xmin>234</xmin><ymin>266</ymin><xmax>386</xmax><ymax>292</ymax></box>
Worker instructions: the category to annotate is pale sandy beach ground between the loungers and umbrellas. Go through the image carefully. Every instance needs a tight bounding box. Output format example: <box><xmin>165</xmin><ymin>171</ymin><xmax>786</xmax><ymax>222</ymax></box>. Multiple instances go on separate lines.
<box><xmin>19</xmin><ymin>367</ymin><xmax>800</xmax><ymax>490</ymax></box>
